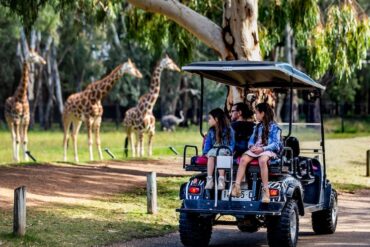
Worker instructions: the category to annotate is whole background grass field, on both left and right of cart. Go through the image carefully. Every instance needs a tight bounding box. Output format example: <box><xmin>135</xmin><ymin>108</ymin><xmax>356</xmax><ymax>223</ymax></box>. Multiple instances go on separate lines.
<box><xmin>0</xmin><ymin>118</ymin><xmax>370</xmax><ymax>165</ymax></box>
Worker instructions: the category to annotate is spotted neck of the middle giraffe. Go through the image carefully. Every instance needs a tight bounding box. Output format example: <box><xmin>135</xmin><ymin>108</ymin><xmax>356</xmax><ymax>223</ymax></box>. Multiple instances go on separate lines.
<box><xmin>85</xmin><ymin>65</ymin><xmax>123</xmax><ymax>101</ymax></box>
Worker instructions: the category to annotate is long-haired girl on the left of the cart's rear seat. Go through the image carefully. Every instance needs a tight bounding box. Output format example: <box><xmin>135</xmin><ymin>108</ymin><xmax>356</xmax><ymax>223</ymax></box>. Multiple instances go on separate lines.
<box><xmin>203</xmin><ymin>108</ymin><xmax>235</xmax><ymax>190</ymax></box>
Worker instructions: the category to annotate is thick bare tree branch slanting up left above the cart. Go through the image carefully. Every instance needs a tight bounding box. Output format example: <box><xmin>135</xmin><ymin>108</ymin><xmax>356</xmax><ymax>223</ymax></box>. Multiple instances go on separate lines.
<box><xmin>128</xmin><ymin>0</ymin><xmax>229</xmax><ymax>59</ymax></box>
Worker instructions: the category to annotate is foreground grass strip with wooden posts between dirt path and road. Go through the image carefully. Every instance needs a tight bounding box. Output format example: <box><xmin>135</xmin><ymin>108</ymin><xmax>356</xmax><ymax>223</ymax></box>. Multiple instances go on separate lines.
<box><xmin>0</xmin><ymin>178</ymin><xmax>186</xmax><ymax>246</ymax></box>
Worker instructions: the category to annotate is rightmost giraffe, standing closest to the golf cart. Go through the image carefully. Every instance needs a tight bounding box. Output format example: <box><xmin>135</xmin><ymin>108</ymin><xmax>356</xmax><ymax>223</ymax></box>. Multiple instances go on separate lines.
<box><xmin>123</xmin><ymin>55</ymin><xmax>180</xmax><ymax>157</ymax></box>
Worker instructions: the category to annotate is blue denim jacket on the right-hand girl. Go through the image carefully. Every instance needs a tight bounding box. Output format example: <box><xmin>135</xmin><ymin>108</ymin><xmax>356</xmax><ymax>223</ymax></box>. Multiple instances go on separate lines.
<box><xmin>248</xmin><ymin>122</ymin><xmax>283</xmax><ymax>154</ymax></box>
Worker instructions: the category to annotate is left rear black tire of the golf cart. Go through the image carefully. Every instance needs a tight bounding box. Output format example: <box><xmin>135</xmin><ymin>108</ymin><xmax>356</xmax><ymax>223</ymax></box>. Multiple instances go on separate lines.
<box><xmin>179</xmin><ymin>213</ymin><xmax>212</xmax><ymax>246</ymax></box>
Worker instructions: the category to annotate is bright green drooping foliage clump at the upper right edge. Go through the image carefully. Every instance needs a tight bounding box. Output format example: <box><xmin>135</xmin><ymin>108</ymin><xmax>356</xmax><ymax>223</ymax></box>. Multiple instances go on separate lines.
<box><xmin>306</xmin><ymin>1</ymin><xmax>370</xmax><ymax>102</ymax></box>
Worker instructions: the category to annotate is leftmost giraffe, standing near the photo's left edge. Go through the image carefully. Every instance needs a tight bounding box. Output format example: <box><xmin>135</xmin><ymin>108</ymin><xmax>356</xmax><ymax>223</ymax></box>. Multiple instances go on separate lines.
<box><xmin>5</xmin><ymin>50</ymin><xmax>46</xmax><ymax>162</ymax></box>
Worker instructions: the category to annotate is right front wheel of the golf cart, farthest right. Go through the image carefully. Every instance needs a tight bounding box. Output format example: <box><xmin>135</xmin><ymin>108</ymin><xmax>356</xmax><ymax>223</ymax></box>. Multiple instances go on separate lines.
<box><xmin>311</xmin><ymin>190</ymin><xmax>338</xmax><ymax>234</ymax></box>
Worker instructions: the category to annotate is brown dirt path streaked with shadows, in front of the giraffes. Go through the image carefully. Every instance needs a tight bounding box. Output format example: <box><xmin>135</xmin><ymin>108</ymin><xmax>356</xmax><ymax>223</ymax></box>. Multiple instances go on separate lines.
<box><xmin>0</xmin><ymin>158</ymin><xmax>186</xmax><ymax>208</ymax></box>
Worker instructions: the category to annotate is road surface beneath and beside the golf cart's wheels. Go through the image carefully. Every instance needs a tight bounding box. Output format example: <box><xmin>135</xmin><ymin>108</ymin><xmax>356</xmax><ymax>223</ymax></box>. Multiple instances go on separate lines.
<box><xmin>111</xmin><ymin>191</ymin><xmax>370</xmax><ymax>247</ymax></box>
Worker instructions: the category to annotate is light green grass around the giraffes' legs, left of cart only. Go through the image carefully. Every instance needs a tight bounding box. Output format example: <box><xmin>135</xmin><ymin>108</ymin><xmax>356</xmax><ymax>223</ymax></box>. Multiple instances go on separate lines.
<box><xmin>0</xmin><ymin>125</ymin><xmax>202</xmax><ymax>164</ymax></box>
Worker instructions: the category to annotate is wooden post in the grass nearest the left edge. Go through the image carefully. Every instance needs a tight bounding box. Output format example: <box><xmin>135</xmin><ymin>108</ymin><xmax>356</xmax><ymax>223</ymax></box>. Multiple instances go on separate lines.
<box><xmin>13</xmin><ymin>186</ymin><xmax>26</xmax><ymax>236</ymax></box>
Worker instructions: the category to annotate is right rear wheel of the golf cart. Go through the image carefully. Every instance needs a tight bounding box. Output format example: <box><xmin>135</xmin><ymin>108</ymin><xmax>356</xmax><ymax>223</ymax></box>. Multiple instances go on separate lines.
<box><xmin>267</xmin><ymin>200</ymin><xmax>299</xmax><ymax>247</ymax></box>
